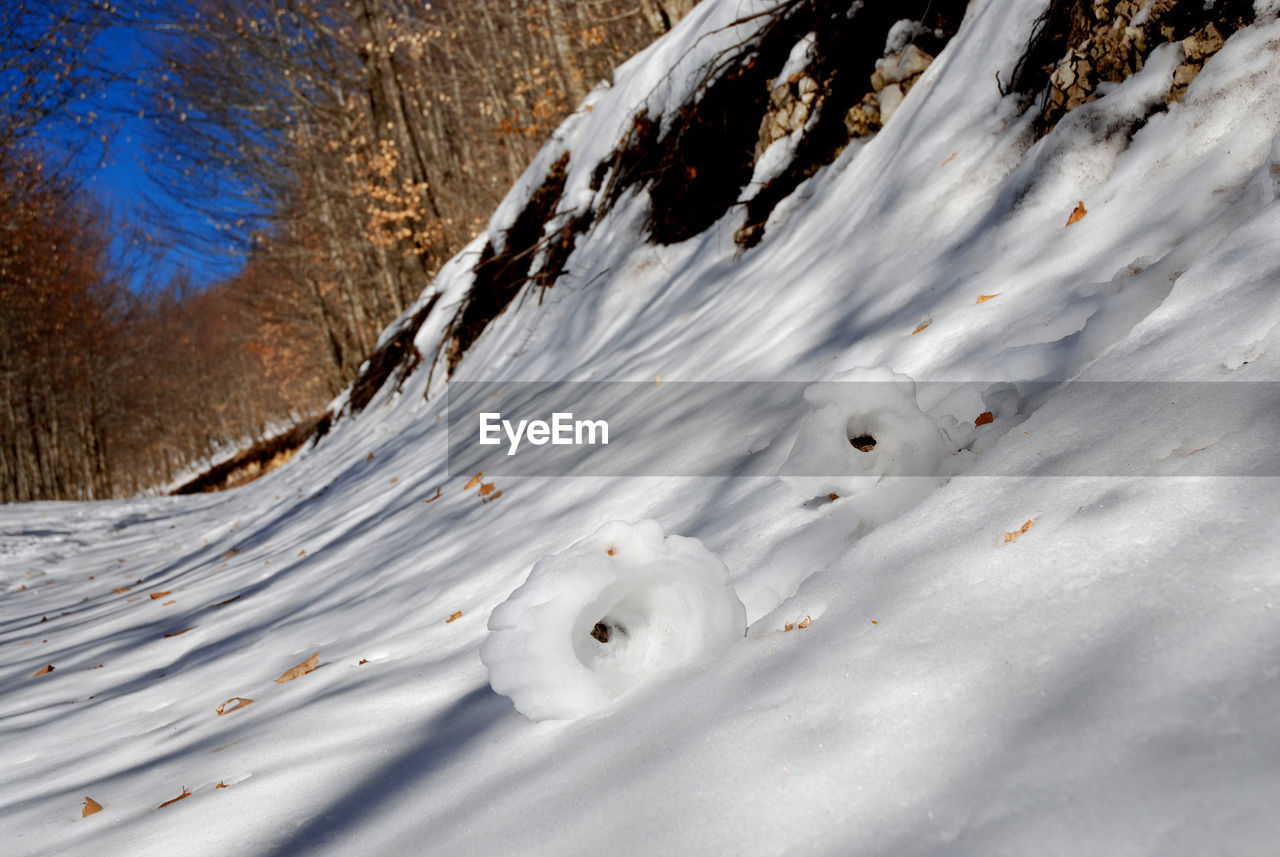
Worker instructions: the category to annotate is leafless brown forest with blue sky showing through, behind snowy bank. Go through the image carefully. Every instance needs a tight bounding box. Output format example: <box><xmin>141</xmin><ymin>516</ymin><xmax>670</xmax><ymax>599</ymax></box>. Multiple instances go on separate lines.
<box><xmin>0</xmin><ymin>0</ymin><xmax>694</xmax><ymax>503</ymax></box>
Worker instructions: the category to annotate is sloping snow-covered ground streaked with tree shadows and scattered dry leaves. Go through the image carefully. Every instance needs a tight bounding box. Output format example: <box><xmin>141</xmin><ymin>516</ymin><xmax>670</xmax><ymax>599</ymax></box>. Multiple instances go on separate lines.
<box><xmin>0</xmin><ymin>0</ymin><xmax>1280</xmax><ymax>856</ymax></box>
